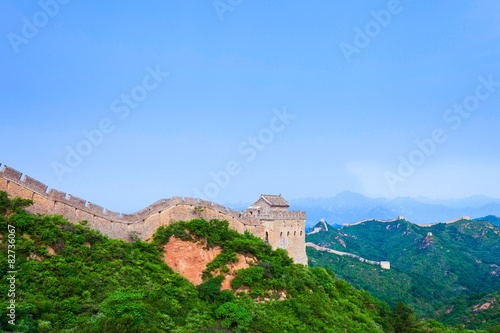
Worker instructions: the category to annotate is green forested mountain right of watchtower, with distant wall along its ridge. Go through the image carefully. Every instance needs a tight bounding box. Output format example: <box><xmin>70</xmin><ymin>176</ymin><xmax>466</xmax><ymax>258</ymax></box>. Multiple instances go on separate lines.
<box><xmin>306</xmin><ymin>220</ymin><xmax>500</xmax><ymax>322</ymax></box>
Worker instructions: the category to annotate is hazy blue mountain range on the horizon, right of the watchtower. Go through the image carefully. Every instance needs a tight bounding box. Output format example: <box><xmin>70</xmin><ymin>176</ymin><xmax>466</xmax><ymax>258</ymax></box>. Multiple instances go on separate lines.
<box><xmin>289</xmin><ymin>191</ymin><xmax>500</xmax><ymax>226</ymax></box>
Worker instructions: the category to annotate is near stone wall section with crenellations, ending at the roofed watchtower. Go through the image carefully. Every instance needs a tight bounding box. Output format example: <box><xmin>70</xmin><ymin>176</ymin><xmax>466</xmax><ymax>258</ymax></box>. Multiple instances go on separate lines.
<box><xmin>0</xmin><ymin>164</ymin><xmax>307</xmax><ymax>265</ymax></box>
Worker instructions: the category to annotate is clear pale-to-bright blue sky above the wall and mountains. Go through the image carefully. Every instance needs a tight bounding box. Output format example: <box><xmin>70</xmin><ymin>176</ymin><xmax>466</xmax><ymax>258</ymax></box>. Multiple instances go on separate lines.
<box><xmin>0</xmin><ymin>0</ymin><xmax>500</xmax><ymax>212</ymax></box>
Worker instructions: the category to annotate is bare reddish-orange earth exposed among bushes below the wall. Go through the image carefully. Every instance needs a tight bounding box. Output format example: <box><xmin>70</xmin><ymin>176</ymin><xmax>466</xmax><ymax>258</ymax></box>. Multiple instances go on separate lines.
<box><xmin>163</xmin><ymin>236</ymin><xmax>255</xmax><ymax>289</ymax></box>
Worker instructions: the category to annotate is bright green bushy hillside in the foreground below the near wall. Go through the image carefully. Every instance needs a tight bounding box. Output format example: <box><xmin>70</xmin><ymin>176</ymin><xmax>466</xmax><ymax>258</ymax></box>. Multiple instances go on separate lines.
<box><xmin>0</xmin><ymin>192</ymin><xmax>480</xmax><ymax>333</ymax></box>
